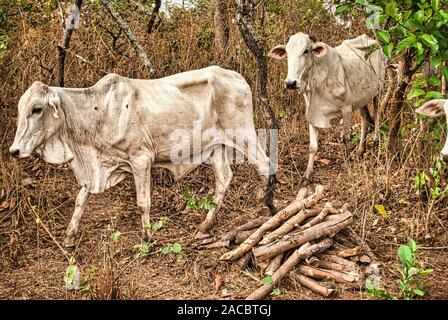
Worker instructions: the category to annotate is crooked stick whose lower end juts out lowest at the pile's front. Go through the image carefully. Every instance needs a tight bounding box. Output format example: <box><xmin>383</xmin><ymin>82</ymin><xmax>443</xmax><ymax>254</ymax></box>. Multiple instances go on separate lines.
<box><xmin>246</xmin><ymin>238</ymin><xmax>333</xmax><ymax>300</ymax></box>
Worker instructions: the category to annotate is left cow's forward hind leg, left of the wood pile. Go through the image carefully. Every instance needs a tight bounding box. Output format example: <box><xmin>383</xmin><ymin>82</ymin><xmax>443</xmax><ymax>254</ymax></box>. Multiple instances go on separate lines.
<box><xmin>199</xmin><ymin>146</ymin><xmax>233</xmax><ymax>234</ymax></box>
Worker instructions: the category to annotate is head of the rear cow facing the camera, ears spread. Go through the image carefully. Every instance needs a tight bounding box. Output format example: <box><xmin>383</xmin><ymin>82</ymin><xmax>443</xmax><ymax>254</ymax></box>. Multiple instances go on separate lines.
<box><xmin>268</xmin><ymin>32</ymin><xmax>327</xmax><ymax>91</ymax></box>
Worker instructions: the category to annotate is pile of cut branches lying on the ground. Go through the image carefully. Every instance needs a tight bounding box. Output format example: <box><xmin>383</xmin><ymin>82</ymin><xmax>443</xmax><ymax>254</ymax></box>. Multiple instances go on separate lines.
<box><xmin>199</xmin><ymin>185</ymin><xmax>375</xmax><ymax>299</ymax></box>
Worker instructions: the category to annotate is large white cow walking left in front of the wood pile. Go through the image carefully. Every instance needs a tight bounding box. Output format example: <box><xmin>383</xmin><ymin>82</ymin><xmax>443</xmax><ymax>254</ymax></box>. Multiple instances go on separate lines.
<box><xmin>10</xmin><ymin>67</ymin><xmax>275</xmax><ymax>248</ymax></box>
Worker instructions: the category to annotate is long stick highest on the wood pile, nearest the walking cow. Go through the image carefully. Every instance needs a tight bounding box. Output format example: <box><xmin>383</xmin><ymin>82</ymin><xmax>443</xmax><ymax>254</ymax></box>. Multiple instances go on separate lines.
<box><xmin>220</xmin><ymin>185</ymin><xmax>325</xmax><ymax>260</ymax></box>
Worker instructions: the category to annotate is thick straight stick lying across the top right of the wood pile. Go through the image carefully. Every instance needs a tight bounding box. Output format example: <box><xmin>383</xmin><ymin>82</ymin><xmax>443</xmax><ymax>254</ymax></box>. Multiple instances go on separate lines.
<box><xmin>252</xmin><ymin>211</ymin><xmax>353</xmax><ymax>261</ymax></box>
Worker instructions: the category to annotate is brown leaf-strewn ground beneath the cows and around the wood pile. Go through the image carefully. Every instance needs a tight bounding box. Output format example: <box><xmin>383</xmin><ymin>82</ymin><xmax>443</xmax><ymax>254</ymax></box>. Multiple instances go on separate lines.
<box><xmin>0</xmin><ymin>115</ymin><xmax>448</xmax><ymax>299</ymax></box>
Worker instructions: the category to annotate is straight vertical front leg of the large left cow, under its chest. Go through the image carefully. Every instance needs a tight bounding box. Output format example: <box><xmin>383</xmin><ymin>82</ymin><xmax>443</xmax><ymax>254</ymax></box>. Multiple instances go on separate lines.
<box><xmin>134</xmin><ymin>167</ymin><xmax>151</xmax><ymax>241</ymax></box>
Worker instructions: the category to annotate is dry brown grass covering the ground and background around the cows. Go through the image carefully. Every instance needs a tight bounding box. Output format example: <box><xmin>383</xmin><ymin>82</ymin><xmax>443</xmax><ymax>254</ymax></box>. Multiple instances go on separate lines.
<box><xmin>0</xmin><ymin>0</ymin><xmax>448</xmax><ymax>299</ymax></box>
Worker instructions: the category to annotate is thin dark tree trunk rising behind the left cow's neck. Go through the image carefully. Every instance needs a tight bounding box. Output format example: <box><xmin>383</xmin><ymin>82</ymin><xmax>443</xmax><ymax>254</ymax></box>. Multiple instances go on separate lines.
<box><xmin>58</xmin><ymin>0</ymin><xmax>83</xmax><ymax>87</ymax></box>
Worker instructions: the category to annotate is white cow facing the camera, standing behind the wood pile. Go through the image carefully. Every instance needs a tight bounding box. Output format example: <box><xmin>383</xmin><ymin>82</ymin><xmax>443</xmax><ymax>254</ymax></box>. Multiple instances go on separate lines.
<box><xmin>268</xmin><ymin>32</ymin><xmax>386</xmax><ymax>183</ymax></box>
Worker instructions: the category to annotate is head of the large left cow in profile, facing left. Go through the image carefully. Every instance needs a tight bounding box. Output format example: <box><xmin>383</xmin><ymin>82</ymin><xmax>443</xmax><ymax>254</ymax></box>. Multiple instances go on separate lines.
<box><xmin>9</xmin><ymin>81</ymin><xmax>71</xmax><ymax>163</ymax></box>
